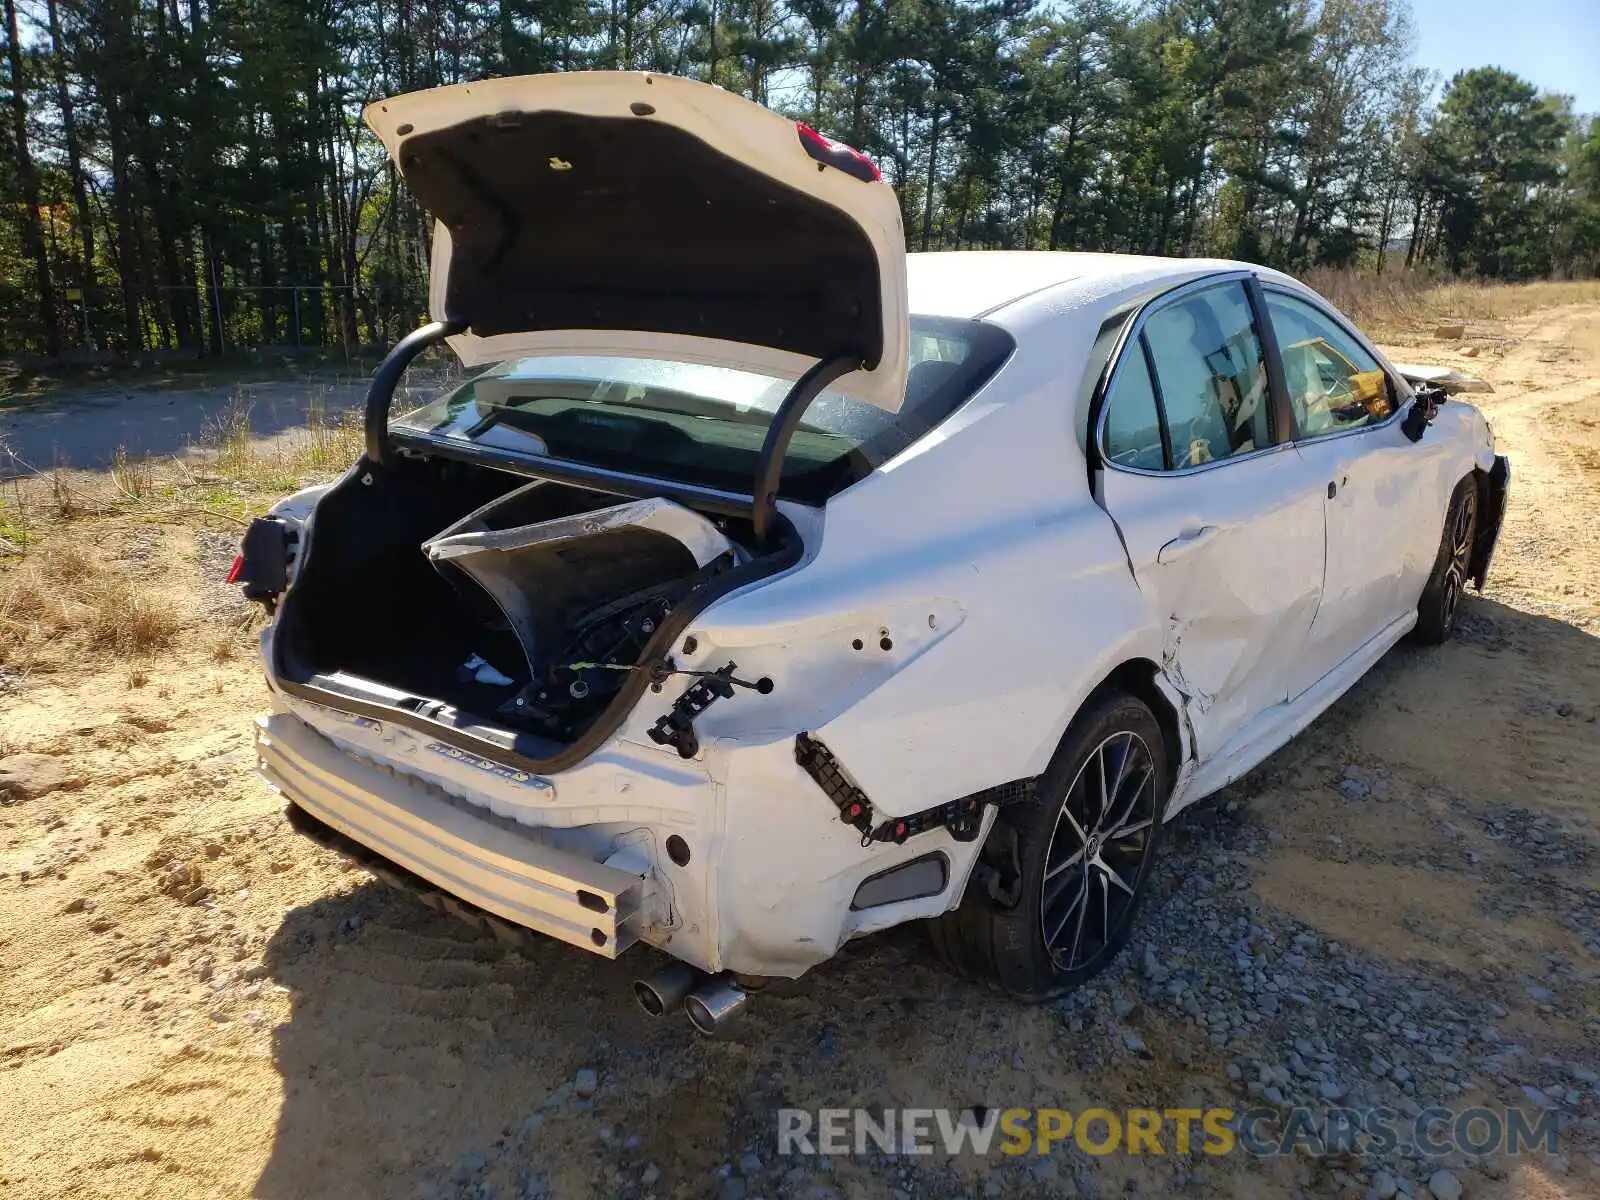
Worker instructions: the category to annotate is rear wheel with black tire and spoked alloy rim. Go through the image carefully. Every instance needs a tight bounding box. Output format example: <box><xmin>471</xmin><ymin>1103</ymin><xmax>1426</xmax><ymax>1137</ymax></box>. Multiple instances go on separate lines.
<box><xmin>930</xmin><ymin>693</ymin><xmax>1168</xmax><ymax>1003</ymax></box>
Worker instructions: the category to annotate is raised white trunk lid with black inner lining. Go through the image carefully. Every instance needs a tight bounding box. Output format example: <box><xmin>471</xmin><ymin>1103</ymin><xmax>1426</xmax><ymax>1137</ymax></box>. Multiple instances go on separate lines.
<box><xmin>365</xmin><ymin>72</ymin><xmax>909</xmax><ymax>411</ymax></box>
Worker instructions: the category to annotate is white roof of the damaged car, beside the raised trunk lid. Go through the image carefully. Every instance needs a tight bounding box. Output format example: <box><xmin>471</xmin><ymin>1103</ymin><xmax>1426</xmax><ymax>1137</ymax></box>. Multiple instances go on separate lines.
<box><xmin>906</xmin><ymin>250</ymin><xmax>1277</xmax><ymax>325</ymax></box>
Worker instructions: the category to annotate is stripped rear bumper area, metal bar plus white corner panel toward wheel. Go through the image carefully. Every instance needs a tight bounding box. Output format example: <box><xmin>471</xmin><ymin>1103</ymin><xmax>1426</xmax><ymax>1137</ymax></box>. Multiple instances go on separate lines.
<box><xmin>258</xmin><ymin>706</ymin><xmax>992</xmax><ymax>978</ymax></box>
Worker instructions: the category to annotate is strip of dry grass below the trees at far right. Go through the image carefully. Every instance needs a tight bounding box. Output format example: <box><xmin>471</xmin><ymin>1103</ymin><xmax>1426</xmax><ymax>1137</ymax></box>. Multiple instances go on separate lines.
<box><xmin>1302</xmin><ymin>269</ymin><xmax>1600</xmax><ymax>334</ymax></box>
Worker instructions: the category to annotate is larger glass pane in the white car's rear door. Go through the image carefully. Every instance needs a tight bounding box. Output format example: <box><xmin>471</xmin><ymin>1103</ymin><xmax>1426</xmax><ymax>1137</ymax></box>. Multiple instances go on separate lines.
<box><xmin>1144</xmin><ymin>283</ymin><xmax>1274</xmax><ymax>469</ymax></box>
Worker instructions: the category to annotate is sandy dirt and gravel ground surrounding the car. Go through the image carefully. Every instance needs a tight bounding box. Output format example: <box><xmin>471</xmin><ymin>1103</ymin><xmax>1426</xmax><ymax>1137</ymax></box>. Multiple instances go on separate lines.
<box><xmin>0</xmin><ymin>307</ymin><xmax>1600</xmax><ymax>1200</ymax></box>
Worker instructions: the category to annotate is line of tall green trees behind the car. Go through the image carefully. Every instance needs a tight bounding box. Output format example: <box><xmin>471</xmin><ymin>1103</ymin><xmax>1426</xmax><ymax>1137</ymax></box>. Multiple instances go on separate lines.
<box><xmin>0</xmin><ymin>0</ymin><xmax>1600</xmax><ymax>355</ymax></box>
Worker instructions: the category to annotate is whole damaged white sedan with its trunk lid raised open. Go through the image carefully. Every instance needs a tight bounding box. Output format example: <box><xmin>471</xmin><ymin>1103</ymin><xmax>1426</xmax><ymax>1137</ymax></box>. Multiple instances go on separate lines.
<box><xmin>235</xmin><ymin>74</ymin><xmax>1509</xmax><ymax>1032</ymax></box>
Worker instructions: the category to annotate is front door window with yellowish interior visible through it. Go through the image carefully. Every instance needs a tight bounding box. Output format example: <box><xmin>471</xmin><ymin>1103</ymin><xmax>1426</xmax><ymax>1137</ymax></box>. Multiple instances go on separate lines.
<box><xmin>1267</xmin><ymin>291</ymin><xmax>1395</xmax><ymax>438</ymax></box>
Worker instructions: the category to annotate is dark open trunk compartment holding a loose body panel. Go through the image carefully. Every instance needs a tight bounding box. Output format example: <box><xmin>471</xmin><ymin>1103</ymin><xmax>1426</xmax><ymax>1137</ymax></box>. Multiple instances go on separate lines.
<box><xmin>274</xmin><ymin>459</ymin><xmax>798</xmax><ymax>760</ymax></box>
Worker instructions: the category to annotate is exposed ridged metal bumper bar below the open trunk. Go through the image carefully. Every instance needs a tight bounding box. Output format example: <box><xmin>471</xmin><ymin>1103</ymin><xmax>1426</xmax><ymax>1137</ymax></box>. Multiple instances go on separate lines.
<box><xmin>256</xmin><ymin>714</ymin><xmax>645</xmax><ymax>958</ymax></box>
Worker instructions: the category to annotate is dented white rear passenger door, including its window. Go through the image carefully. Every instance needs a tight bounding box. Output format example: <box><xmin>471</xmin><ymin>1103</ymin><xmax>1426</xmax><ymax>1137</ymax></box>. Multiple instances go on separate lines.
<box><xmin>1098</xmin><ymin>280</ymin><xmax>1323</xmax><ymax>760</ymax></box>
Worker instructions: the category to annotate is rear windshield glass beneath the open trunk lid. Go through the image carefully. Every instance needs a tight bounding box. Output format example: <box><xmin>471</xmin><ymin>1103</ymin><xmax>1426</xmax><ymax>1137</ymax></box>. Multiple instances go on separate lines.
<box><xmin>394</xmin><ymin>317</ymin><xmax>1013</xmax><ymax>504</ymax></box>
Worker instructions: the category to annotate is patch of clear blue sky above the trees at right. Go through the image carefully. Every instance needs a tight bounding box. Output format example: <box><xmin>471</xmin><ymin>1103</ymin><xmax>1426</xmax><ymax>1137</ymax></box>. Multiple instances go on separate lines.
<box><xmin>1411</xmin><ymin>0</ymin><xmax>1600</xmax><ymax>114</ymax></box>
